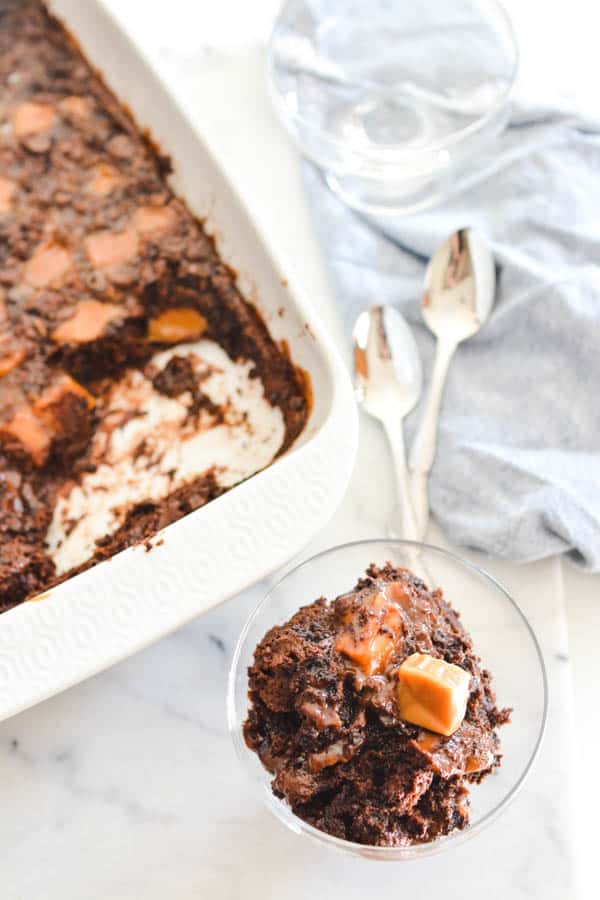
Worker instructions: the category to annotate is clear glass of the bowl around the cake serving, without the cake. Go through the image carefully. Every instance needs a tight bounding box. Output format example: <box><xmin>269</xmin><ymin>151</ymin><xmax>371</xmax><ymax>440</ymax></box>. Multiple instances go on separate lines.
<box><xmin>228</xmin><ymin>540</ymin><xmax>547</xmax><ymax>860</ymax></box>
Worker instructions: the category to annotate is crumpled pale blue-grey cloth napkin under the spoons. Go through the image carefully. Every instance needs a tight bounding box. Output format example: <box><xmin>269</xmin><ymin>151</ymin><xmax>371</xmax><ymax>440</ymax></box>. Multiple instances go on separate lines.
<box><xmin>306</xmin><ymin>106</ymin><xmax>600</xmax><ymax>571</ymax></box>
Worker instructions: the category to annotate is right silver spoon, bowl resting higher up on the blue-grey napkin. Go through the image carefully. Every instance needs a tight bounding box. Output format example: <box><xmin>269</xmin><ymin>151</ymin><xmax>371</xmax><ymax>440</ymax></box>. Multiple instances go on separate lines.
<box><xmin>410</xmin><ymin>228</ymin><xmax>496</xmax><ymax>540</ymax></box>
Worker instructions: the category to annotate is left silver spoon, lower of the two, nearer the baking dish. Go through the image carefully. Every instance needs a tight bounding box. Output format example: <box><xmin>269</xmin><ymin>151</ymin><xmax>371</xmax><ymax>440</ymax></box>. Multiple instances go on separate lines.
<box><xmin>353</xmin><ymin>306</ymin><xmax>423</xmax><ymax>541</ymax></box>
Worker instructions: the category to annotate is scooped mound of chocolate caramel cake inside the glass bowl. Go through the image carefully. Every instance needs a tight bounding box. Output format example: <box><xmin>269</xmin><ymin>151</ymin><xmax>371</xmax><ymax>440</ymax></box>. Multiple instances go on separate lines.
<box><xmin>244</xmin><ymin>564</ymin><xmax>510</xmax><ymax>846</ymax></box>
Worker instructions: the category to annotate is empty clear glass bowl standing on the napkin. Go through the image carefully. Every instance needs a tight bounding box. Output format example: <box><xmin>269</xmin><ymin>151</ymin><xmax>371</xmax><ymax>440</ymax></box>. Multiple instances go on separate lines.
<box><xmin>268</xmin><ymin>0</ymin><xmax>518</xmax><ymax>214</ymax></box>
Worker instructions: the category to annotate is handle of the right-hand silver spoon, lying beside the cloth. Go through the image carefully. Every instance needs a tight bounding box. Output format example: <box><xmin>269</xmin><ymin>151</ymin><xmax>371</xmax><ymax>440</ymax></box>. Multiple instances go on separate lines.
<box><xmin>409</xmin><ymin>340</ymin><xmax>457</xmax><ymax>540</ymax></box>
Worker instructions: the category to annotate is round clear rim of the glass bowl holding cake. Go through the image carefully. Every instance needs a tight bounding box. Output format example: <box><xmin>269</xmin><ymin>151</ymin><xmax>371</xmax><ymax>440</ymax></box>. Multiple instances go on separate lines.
<box><xmin>227</xmin><ymin>538</ymin><xmax>549</xmax><ymax>860</ymax></box>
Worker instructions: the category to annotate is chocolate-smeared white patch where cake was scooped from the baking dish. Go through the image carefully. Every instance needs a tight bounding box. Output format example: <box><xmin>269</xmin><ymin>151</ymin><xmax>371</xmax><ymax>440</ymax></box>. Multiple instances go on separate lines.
<box><xmin>46</xmin><ymin>340</ymin><xmax>285</xmax><ymax>574</ymax></box>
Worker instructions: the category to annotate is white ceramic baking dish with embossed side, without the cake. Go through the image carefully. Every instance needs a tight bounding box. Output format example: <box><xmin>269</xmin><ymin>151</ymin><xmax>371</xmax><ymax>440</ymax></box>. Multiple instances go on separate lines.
<box><xmin>0</xmin><ymin>0</ymin><xmax>357</xmax><ymax>719</ymax></box>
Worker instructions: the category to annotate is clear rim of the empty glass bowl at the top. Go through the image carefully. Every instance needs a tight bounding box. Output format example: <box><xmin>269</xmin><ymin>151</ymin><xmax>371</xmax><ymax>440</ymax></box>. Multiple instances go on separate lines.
<box><xmin>266</xmin><ymin>0</ymin><xmax>521</xmax><ymax>167</ymax></box>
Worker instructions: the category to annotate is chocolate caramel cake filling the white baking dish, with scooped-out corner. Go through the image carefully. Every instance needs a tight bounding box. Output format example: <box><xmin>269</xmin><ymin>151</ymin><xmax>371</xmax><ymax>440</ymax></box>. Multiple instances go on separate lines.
<box><xmin>0</xmin><ymin>0</ymin><xmax>308</xmax><ymax>611</ymax></box>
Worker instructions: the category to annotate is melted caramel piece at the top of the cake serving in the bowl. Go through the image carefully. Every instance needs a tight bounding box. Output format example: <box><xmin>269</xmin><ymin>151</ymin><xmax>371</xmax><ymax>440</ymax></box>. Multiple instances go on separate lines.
<box><xmin>335</xmin><ymin>591</ymin><xmax>402</xmax><ymax>675</ymax></box>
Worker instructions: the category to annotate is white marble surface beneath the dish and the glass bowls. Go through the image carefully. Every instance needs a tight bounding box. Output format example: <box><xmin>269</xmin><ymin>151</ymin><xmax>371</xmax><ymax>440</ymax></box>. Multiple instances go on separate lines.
<box><xmin>0</xmin><ymin>0</ymin><xmax>600</xmax><ymax>900</ymax></box>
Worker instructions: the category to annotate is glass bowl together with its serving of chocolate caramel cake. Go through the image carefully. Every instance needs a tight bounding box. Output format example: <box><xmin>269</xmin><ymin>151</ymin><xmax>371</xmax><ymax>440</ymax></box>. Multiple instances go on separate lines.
<box><xmin>230</xmin><ymin>541</ymin><xmax>545</xmax><ymax>858</ymax></box>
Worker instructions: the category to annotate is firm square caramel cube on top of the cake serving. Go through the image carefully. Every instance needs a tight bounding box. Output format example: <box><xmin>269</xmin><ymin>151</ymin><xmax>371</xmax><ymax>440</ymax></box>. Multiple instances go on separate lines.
<box><xmin>396</xmin><ymin>653</ymin><xmax>471</xmax><ymax>737</ymax></box>
